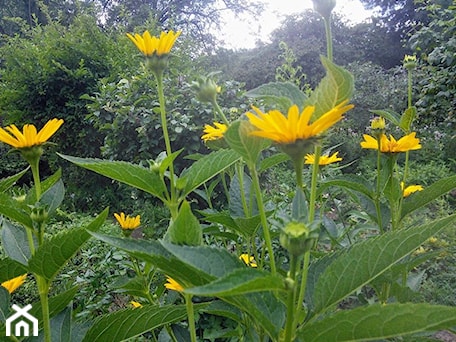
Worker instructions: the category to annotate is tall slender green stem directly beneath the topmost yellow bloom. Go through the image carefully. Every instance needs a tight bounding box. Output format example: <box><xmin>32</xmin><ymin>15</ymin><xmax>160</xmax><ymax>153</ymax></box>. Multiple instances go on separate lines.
<box><xmin>154</xmin><ymin>72</ymin><xmax>179</xmax><ymax>219</ymax></box>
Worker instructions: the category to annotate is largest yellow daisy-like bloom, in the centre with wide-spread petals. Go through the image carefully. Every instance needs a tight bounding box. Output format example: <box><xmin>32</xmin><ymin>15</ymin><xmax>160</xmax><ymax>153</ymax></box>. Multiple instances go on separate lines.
<box><xmin>246</xmin><ymin>101</ymin><xmax>353</xmax><ymax>144</ymax></box>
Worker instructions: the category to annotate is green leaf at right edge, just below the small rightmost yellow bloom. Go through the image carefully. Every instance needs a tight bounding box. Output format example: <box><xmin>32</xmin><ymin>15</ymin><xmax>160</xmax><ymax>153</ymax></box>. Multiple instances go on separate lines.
<box><xmin>401</xmin><ymin>176</ymin><xmax>456</xmax><ymax>218</ymax></box>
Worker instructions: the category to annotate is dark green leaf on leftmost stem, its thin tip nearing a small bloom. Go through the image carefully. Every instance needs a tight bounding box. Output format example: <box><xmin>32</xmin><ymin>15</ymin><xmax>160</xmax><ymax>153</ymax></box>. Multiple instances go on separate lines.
<box><xmin>29</xmin><ymin>208</ymin><xmax>109</xmax><ymax>281</ymax></box>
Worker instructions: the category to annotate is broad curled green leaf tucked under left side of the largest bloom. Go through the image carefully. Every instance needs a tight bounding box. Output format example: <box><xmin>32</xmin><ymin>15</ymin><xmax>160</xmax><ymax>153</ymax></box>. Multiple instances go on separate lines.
<box><xmin>224</xmin><ymin>120</ymin><xmax>270</xmax><ymax>165</ymax></box>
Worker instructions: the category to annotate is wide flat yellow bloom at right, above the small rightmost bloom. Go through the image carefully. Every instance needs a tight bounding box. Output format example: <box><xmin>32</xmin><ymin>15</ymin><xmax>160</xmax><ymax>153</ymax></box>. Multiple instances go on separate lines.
<box><xmin>361</xmin><ymin>132</ymin><xmax>421</xmax><ymax>153</ymax></box>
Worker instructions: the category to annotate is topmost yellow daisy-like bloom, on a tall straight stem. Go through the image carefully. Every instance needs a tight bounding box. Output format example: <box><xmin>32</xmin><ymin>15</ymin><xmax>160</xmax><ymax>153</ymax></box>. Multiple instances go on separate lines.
<box><xmin>127</xmin><ymin>31</ymin><xmax>181</xmax><ymax>57</ymax></box>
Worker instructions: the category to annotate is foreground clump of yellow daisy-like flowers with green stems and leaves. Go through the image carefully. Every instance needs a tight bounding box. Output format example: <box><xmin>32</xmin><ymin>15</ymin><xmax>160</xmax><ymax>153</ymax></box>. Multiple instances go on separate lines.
<box><xmin>0</xmin><ymin>0</ymin><xmax>456</xmax><ymax>342</ymax></box>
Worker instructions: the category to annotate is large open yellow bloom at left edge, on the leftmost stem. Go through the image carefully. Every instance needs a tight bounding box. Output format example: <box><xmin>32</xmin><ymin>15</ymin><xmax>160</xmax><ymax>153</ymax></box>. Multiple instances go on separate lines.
<box><xmin>0</xmin><ymin>119</ymin><xmax>63</xmax><ymax>149</ymax></box>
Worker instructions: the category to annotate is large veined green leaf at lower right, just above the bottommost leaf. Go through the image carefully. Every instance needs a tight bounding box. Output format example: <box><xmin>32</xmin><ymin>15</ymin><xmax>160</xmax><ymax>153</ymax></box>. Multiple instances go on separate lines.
<box><xmin>314</xmin><ymin>215</ymin><xmax>456</xmax><ymax>313</ymax></box>
